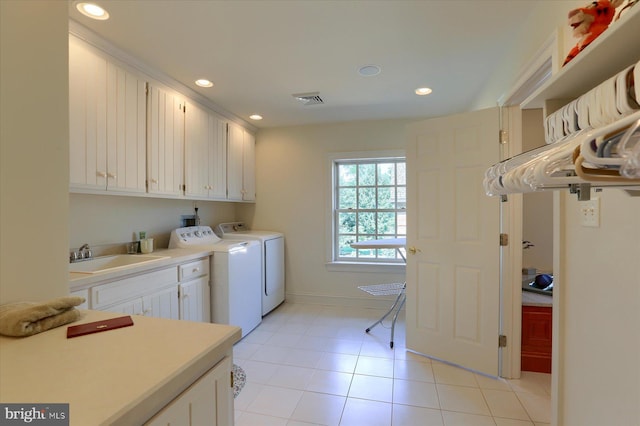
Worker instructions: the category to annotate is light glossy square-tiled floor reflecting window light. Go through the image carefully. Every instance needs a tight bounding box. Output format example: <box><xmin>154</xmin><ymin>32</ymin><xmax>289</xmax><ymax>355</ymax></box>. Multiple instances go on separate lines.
<box><xmin>234</xmin><ymin>303</ymin><xmax>551</xmax><ymax>426</ymax></box>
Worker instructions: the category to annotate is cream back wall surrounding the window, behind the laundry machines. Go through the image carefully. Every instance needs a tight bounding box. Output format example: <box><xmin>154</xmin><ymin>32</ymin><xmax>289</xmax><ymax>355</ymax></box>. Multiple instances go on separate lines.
<box><xmin>238</xmin><ymin>120</ymin><xmax>407</xmax><ymax>304</ymax></box>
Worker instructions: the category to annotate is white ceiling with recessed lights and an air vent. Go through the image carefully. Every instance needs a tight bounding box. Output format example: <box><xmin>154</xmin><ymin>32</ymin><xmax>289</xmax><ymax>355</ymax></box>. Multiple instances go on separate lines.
<box><xmin>69</xmin><ymin>0</ymin><xmax>539</xmax><ymax>127</ymax></box>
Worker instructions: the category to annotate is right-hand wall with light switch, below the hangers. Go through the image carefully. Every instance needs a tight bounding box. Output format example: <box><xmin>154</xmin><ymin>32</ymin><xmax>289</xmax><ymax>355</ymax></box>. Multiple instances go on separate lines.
<box><xmin>554</xmin><ymin>189</ymin><xmax>640</xmax><ymax>426</ymax></box>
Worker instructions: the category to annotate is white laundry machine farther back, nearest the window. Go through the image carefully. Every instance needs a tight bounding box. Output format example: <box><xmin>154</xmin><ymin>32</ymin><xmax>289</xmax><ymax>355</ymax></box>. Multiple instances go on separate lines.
<box><xmin>215</xmin><ymin>222</ymin><xmax>284</xmax><ymax>315</ymax></box>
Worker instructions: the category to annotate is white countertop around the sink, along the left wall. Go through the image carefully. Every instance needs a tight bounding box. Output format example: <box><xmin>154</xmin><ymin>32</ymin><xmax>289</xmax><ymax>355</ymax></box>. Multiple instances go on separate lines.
<box><xmin>69</xmin><ymin>247</ymin><xmax>213</xmax><ymax>291</ymax></box>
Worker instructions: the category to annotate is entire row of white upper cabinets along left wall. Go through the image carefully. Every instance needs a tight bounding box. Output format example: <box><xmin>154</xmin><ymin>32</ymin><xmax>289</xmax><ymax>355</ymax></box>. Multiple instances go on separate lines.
<box><xmin>69</xmin><ymin>34</ymin><xmax>255</xmax><ymax>202</ymax></box>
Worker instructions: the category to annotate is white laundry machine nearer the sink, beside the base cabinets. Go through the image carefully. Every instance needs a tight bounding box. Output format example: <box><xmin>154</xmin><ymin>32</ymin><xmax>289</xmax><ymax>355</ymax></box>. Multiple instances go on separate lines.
<box><xmin>169</xmin><ymin>226</ymin><xmax>262</xmax><ymax>337</ymax></box>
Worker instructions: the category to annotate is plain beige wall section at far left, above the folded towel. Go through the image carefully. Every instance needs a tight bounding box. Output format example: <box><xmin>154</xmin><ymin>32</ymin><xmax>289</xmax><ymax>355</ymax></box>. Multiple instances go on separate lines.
<box><xmin>0</xmin><ymin>0</ymin><xmax>69</xmax><ymax>304</ymax></box>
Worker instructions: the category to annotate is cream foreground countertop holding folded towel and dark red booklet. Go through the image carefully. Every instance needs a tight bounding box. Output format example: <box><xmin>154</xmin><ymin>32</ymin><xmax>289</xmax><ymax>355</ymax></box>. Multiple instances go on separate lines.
<box><xmin>0</xmin><ymin>311</ymin><xmax>241</xmax><ymax>426</ymax></box>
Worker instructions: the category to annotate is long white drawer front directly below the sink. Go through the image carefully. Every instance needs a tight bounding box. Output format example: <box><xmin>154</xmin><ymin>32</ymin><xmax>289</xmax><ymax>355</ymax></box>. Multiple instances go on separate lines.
<box><xmin>91</xmin><ymin>267</ymin><xmax>178</xmax><ymax>309</ymax></box>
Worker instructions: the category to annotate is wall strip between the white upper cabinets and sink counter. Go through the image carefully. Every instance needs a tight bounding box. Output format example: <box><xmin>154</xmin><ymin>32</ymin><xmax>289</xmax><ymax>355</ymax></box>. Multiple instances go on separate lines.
<box><xmin>69</xmin><ymin>194</ymin><xmax>236</xmax><ymax>250</ymax></box>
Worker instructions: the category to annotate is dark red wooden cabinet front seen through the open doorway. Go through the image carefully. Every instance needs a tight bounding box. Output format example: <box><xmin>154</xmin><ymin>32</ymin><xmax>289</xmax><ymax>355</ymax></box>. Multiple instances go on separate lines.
<box><xmin>521</xmin><ymin>306</ymin><xmax>552</xmax><ymax>373</ymax></box>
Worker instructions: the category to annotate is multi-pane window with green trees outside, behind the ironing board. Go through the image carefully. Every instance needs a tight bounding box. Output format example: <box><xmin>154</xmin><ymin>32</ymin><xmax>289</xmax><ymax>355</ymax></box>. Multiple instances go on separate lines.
<box><xmin>333</xmin><ymin>157</ymin><xmax>407</xmax><ymax>263</ymax></box>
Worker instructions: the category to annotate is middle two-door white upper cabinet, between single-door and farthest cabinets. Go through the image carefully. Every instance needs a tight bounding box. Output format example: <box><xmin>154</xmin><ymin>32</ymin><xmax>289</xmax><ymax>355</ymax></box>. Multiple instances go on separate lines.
<box><xmin>185</xmin><ymin>103</ymin><xmax>227</xmax><ymax>200</ymax></box>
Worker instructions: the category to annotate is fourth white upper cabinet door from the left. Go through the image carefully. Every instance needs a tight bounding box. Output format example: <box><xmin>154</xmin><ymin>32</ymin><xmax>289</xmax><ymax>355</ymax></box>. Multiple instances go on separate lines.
<box><xmin>184</xmin><ymin>103</ymin><xmax>209</xmax><ymax>199</ymax></box>
